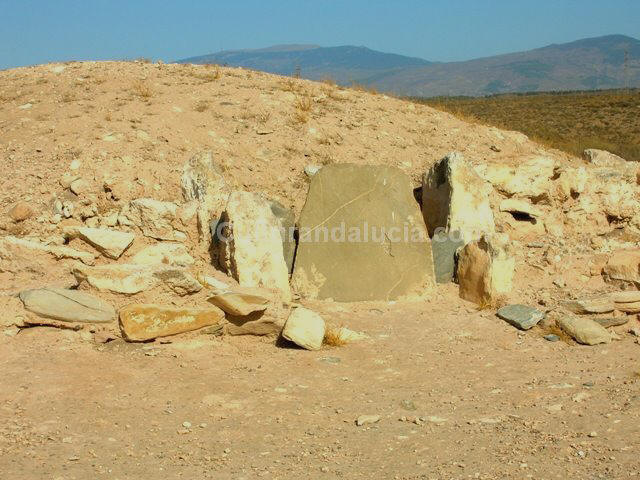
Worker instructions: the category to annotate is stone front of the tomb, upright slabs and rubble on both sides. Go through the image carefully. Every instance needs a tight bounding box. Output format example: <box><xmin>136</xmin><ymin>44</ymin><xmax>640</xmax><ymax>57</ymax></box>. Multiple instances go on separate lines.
<box><xmin>5</xmin><ymin>146</ymin><xmax>640</xmax><ymax>350</ymax></box>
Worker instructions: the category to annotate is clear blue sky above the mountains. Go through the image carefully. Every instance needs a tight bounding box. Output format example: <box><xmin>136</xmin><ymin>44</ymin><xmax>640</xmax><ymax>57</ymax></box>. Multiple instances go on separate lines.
<box><xmin>0</xmin><ymin>0</ymin><xmax>640</xmax><ymax>69</ymax></box>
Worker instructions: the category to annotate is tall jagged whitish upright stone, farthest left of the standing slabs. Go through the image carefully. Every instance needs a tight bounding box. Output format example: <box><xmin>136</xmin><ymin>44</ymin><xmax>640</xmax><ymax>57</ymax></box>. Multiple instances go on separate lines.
<box><xmin>181</xmin><ymin>151</ymin><xmax>230</xmax><ymax>240</ymax></box>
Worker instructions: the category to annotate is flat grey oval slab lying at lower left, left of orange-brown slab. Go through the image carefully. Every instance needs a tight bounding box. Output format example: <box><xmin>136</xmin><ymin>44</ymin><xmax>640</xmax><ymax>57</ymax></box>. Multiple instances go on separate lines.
<box><xmin>20</xmin><ymin>288</ymin><xmax>116</xmax><ymax>323</ymax></box>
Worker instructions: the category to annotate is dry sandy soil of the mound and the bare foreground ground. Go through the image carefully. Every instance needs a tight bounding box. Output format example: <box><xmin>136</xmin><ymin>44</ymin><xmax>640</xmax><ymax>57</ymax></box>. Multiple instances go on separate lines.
<box><xmin>0</xmin><ymin>63</ymin><xmax>640</xmax><ymax>480</ymax></box>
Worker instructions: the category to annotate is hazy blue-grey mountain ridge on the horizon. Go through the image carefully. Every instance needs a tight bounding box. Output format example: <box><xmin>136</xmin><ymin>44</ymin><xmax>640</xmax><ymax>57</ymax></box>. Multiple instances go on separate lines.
<box><xmin>180</xmin><ymin>35</ymin><xmax>640</xmax><ymax>97</ymax></box>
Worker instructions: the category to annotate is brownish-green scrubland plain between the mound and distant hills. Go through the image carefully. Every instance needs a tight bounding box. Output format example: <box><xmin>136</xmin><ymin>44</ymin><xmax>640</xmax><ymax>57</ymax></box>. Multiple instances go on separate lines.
<box><xmin>413</xmin><ymin>89</ymin><xmax>640</xmax><ymax>161</ymax></box>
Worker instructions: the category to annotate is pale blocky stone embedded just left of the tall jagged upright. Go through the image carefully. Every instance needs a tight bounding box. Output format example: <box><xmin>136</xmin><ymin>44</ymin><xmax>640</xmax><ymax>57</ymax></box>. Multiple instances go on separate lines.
<box><xmin>123</xmin><ymin>198</ymin><xmax>182</xmax><ymax>240</ymax></box>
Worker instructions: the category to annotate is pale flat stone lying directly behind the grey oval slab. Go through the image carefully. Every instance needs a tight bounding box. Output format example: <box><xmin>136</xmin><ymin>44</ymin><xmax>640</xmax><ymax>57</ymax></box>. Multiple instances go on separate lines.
<box><xmin>72</xmin><ymin>264</ymin><xmax>160</xmax><ymax>295</ymax></box>
